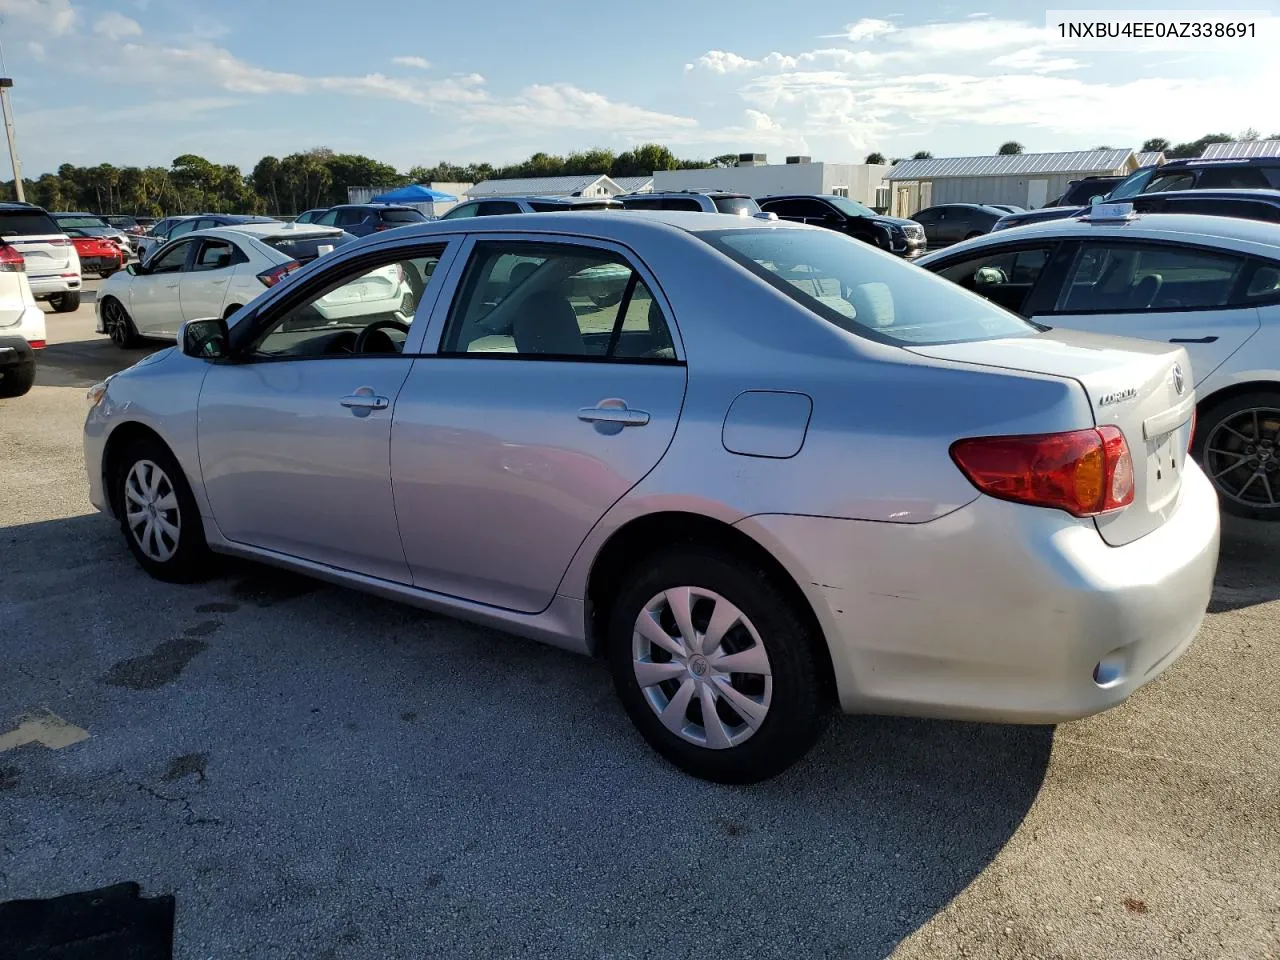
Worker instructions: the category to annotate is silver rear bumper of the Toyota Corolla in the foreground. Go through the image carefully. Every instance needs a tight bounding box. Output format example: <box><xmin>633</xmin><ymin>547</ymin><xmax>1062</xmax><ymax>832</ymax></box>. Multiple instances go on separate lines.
<box><xmin>741</xmin><ymin>466</ymin><xmax>1219</xmax><ymax>723</ymax></box>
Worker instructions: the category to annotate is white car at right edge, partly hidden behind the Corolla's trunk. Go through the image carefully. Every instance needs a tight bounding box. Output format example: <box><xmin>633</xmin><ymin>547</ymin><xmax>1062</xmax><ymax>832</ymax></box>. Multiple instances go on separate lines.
<box><xmin>916</xmin><ymin>205</ymin><xmax>1280</xmax><ymax>521</ymax></box>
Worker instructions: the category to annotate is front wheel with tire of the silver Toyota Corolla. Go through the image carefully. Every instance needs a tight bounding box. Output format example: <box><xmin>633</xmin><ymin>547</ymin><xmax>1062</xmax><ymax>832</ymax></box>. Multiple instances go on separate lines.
<box><xmin>111</xmin><ymin>438</ymin><xmax>212</xmax><ymax>584</ymax></box>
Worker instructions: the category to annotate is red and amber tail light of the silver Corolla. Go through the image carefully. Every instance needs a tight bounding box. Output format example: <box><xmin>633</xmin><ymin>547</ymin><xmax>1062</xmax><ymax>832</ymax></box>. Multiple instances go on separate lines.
<box><xmin>951</xmin><ymin>424</ymin><xmax>1134</xmax><ymax>517</ymax></box>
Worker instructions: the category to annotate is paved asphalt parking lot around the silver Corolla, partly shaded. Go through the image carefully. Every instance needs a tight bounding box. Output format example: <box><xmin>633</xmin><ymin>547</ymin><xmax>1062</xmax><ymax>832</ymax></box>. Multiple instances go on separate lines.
<box><xmin>0</xmin><ymin>284</ymin><xmax>1280</xmax><ymax>960</ymax></box>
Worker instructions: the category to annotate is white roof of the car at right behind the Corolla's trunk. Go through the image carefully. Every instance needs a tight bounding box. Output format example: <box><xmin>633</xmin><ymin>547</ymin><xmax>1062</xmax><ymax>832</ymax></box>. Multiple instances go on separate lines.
<box><xmin>916</xmin><ymin>214</ymin><xmax>1280</xmax><ymax>264</ymax></box>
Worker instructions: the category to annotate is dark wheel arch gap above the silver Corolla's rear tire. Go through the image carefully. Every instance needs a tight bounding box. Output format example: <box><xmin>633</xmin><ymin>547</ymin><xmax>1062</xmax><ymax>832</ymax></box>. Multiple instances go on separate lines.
<box><xmin>584</xmin><ymin>511</ymin><xmax>836</xmax><ymax>694</ymax></box>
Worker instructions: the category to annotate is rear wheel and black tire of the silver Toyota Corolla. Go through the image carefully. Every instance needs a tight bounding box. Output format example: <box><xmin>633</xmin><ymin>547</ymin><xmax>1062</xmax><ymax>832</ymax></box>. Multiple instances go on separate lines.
<box><xmin>605</xmin><ymin>547</ymin><xmax>829</xmax><ymax>783</ymax></box>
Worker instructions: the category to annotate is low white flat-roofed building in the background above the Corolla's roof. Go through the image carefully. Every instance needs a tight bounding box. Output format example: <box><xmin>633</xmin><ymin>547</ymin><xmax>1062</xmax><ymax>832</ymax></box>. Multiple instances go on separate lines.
<box><xmin>653</xmin><ymin>154</ymin><xmax>891</xmax><ymax>207</ymax></box>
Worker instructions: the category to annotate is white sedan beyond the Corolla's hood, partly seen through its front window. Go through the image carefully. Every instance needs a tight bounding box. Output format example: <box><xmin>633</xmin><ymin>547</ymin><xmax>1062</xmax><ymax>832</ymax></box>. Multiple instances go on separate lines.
<box><xmin>96</xmin><ymin>221</ymin><xmax>412</xmax><ymax>348</ymax></box>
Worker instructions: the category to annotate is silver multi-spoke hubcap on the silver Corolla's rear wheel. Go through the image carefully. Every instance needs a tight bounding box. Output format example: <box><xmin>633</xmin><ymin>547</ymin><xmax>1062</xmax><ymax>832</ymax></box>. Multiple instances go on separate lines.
<box><xmin>631</xmin><ymin>586</ymin><xmax>773</xmax><ymax>750</ymax></box>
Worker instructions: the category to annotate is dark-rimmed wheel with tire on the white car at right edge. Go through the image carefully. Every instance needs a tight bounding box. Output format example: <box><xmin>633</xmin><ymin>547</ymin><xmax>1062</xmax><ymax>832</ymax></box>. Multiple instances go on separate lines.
<box><xmin>1192</xmin><ymin>390</ymin><xmax>1280</xmax><ymax>522</ymax></box>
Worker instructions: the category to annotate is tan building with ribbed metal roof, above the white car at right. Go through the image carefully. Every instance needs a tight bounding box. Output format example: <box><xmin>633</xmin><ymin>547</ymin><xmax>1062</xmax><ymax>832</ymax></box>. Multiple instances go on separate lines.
<box><xmin>884</xmin><ymin>147</ymin><xmax>1138</xmax><ymax>216</ymax></box>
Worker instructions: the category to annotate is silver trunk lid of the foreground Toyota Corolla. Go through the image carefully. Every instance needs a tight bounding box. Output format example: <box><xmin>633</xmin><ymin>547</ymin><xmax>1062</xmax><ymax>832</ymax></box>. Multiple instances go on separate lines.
<box><xmin>908</xmin><ymin>330</ymin><xmax>1196</xmax><ymax>547</ymax></box>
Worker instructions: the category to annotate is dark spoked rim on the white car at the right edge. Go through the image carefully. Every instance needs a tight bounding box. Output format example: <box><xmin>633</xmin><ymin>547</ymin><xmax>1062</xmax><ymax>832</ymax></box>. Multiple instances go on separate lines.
<box><xmin>1204</xmin><ymin>407</ymin><xmax>1280</xmax><ymax>509</ymax></box>
